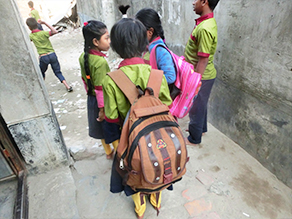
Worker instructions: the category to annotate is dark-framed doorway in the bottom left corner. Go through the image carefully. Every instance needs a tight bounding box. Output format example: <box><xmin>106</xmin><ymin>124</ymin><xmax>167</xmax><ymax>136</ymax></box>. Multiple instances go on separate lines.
<box><xmin>0</xmin><ymin>113</ymin><xmax>28</xmax><ymax>219</ymax></box>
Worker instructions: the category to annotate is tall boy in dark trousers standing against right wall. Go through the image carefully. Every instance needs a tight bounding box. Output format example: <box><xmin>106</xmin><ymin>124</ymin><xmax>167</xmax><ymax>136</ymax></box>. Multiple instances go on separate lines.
<box><xmin>184</xmin><ymin>0</ymin><xmax>219</xmax><ymax>145</ymax></box>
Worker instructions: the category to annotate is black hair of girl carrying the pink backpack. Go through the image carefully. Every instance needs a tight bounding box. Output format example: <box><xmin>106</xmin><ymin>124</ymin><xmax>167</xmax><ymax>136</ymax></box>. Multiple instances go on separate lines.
<box><xmin>135</xmin><ymin>8</ymin><xmax>165</xmax><ymax>42</ymax></box>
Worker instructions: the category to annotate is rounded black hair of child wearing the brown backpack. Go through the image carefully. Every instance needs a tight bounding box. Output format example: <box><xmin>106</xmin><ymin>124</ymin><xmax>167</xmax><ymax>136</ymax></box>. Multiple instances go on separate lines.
<box><xmin>110</xmin><ymin>18</ymin><xmax>148</xmax><ymax>59</ymax></box>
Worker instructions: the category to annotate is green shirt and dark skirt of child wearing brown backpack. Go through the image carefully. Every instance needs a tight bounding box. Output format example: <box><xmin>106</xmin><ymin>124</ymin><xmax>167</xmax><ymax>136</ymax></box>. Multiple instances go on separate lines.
<box><xmin>103</xmin><ymin>57</ymin><xmax>172</xmax><ymax>192</ymax></box>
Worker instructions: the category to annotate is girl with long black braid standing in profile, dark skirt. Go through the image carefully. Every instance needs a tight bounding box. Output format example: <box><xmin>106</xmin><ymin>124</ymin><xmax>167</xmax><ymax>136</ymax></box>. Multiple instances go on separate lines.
<box><xmin>79</xmin><ymin>20</ymin><xmax>120</xmax><ymax>159</ymax></box>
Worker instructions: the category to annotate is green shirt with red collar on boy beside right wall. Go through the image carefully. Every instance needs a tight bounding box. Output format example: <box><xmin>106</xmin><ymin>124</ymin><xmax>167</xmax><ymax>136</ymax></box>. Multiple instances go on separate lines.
<box><xmin>184</xmin><ymin>13</ymin><xmax>217</xmax><ymax>80</ymax></box>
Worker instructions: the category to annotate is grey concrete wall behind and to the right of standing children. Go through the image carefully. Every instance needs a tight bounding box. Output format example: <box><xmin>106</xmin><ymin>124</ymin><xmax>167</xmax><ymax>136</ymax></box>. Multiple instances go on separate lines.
<box><xmin>77</xmin><ymin>0</ymin><xmax>292</xmax><ymax>187</ymax></box>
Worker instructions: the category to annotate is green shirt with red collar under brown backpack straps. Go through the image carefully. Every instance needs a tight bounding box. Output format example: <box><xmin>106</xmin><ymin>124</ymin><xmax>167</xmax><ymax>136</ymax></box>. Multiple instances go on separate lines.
<box><xmin>102</xmin><ymin>58</ymin><xmax>172</xmax><ymax>122</ymax></box>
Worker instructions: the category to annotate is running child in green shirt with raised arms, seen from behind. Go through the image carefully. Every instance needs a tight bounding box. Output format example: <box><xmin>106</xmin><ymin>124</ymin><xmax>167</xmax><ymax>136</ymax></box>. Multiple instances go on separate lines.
<box><xmin>26</xmin><ymin>17</ymin><xmax>73</xmax><ymax>92</ymax></box>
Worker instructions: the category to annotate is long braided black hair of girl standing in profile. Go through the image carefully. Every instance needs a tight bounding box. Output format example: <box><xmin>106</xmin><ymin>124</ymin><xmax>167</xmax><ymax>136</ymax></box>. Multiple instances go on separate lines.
<box><xmin>82</xmin><ymin>20</ymin><xmax>107</xmax><ymax>94</ymax></box>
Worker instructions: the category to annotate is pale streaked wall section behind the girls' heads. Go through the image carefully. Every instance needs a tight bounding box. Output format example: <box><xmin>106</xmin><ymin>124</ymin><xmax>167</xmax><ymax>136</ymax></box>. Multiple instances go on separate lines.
<box><xmin>77</xmin><ymin>0</ymin><xmax>197</xmax><ymax>55</ymax></box>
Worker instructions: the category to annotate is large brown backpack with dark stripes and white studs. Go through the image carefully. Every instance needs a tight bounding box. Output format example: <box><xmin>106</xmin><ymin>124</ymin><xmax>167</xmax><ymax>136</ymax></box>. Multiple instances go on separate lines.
<box><xmin>108</xmin><ymin>70</ymin><xmax>188</xmax><ymax>194</ymax></box>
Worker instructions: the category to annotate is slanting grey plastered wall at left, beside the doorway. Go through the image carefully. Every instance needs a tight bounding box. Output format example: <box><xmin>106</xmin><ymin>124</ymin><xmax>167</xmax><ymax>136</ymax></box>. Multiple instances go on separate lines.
<box><xmin>0</xmin><ymin>0</ymin><xmax>68</xmax><ymax>173</ymax></box>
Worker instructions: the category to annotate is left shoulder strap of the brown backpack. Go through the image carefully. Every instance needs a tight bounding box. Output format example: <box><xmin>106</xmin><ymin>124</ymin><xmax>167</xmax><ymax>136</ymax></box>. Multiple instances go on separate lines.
<box><xmin>107</xmin><ymin>69</ymin><xmax>139</xmax><ymax>104</ymax></box>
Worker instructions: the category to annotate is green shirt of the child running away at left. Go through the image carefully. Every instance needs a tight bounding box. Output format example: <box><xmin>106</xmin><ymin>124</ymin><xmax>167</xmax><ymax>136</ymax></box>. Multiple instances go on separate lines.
<box><xmin>29</xmin><ymin>30</ymin><xmax>55</xmax><ymax>55</ymax></box>
